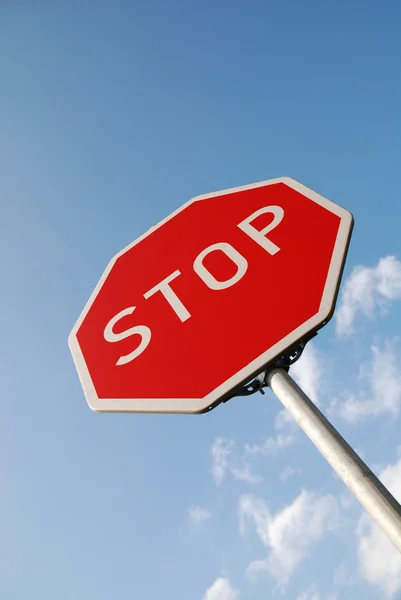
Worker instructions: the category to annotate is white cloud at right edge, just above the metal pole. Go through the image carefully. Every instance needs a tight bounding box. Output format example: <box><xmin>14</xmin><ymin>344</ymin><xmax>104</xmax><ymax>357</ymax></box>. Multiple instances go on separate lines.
<box><xmin>339</xmin><ymin>340</ymin><xmax>401</xmax><ymax>421</ymax></box>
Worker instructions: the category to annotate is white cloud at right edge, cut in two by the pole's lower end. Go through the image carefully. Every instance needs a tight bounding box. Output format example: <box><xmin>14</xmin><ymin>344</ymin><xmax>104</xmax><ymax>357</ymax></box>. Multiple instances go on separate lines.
<box><xmin>356</xmin><ymin>459</ymin><xmax>401</xmax><ymax>598</ymax></box>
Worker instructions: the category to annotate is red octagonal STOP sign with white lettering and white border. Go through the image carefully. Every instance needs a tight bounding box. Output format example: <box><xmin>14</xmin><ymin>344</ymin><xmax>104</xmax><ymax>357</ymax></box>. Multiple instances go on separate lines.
<box><xmin>69</xmin><ymin>178</ymin><xmax>352</xmax><ymax>413</ymax></box>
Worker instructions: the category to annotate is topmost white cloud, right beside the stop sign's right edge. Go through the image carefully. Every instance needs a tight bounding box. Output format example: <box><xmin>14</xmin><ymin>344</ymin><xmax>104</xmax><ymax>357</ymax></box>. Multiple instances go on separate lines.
<box><xmin>336</xmin><ymin>256</ymin><xmax>401</xmax><ymax>337</ymax></box>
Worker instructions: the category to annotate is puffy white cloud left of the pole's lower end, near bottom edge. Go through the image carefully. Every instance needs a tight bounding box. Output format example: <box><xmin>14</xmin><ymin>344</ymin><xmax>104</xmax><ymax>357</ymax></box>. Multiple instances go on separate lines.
<box><xmin>239</xmin><ymin>491</ymin><xmax>339</xmax><ymax>586</ymax></box>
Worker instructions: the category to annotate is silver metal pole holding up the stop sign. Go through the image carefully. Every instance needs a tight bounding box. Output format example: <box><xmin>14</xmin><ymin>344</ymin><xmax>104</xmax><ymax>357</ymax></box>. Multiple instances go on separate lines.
<box><xmin>266</xmin><ymin>368</ymin><xmax>401</xmax><ymax>552</ymax></box>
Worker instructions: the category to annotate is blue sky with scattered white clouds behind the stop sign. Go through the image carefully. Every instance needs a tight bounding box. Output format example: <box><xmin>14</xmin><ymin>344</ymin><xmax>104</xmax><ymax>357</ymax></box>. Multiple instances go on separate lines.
<box><xmin>0</xmin><ymin>0</ymin><xmax>401</xmax><ymax>600</ymax></box>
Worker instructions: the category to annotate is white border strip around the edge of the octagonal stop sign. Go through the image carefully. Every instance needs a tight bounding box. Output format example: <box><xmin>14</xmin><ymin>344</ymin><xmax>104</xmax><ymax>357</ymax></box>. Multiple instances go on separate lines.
<box><xmin>68</xmin><ymin>177</ymin><xmax>354</xmax><ymax>414</ymax></box>
